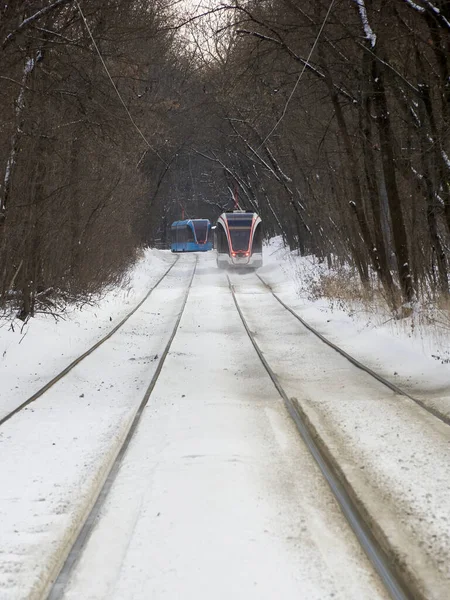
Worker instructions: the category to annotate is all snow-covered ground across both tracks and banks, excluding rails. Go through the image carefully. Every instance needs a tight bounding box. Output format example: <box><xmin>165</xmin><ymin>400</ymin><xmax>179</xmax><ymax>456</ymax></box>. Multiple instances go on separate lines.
<box><xmin>0</xmin><ymin>241</ymin><xmax>450</xmax><ymax>600</ymax></box>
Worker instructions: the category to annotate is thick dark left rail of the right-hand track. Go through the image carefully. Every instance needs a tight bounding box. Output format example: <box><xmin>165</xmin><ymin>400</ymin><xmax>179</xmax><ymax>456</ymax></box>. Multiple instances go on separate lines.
<box><xmin>227</xmin><ymin>275</ymin><xmax>417</xmax><ymax>600</ymax></box>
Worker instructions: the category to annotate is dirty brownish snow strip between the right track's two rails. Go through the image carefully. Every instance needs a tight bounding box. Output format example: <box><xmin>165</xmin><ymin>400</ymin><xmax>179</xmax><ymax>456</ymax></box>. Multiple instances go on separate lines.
<box><xmin>231</xmin><ymin>273</ymin><xmax>450</xmax><ymax>599</ymax></box>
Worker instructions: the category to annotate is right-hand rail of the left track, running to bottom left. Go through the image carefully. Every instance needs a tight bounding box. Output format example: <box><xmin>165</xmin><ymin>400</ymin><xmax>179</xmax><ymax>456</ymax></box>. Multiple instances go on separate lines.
<box><xmin>46</xmin><ymin>257</ymin><xmax>198</xmax><ymax>600</ymax></box>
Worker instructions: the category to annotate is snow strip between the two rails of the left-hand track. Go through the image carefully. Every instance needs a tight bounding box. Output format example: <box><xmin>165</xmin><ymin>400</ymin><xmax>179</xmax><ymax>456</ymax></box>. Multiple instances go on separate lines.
<box><xmin>0</xmin><ymin>257</ymin><xmax>193</xmax><ymax>600</ymax></box>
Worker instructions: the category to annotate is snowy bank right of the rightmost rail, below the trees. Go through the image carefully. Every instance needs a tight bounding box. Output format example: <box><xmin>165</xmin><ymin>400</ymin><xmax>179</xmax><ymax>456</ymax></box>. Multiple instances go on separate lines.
<box><xmin>258</xmin><ymin>238</ymin><xmax>450</xmax><ymax>416</ymax></box>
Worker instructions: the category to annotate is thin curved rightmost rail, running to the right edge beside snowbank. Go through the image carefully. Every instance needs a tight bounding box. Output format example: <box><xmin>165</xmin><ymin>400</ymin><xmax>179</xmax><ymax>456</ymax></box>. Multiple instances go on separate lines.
<box><xmin>255</xmin><ymin>273</ymin><xmax>450</xmax><ymax>425</ymax></box>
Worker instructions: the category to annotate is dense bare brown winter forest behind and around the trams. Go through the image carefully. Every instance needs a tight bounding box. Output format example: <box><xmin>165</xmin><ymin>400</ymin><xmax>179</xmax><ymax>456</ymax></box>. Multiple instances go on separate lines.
<box><xmin>0</xmin><ymin>0</ymin><xmax>450</xmax><ymax>320</ymax></box>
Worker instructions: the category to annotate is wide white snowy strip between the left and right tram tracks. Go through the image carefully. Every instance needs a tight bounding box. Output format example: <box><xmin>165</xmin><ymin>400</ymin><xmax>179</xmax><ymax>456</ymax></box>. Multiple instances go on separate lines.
<box><xmin>56</xmin><ymin>256</ymin><xmax>385</xmax><ymax>600</ymax></box>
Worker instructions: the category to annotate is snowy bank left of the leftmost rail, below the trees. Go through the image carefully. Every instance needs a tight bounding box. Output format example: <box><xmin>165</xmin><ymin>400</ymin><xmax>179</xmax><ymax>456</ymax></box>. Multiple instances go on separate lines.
<box><xmin>0</xmin><ymin>249</ymin><xmax>174</xmax><ymax>418</ymax></box>
